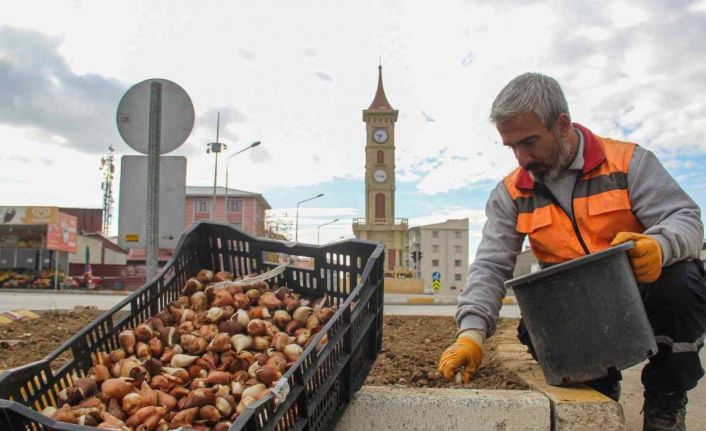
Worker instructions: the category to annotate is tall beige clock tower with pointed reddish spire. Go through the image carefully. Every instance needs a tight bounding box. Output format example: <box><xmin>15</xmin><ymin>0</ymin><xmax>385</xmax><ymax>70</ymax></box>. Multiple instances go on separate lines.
<box><xmin>353</xmin><ymin>66</ymin><xmax>408</xmax><ymax>271</ymax></box>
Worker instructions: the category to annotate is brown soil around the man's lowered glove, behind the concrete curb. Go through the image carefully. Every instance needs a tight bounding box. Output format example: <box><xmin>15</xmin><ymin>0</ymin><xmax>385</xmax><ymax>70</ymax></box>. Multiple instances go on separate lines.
<box><xmin>365</xmin><ymin>316</ymin><xmax>527</xmax><ymax>389</ymax></box>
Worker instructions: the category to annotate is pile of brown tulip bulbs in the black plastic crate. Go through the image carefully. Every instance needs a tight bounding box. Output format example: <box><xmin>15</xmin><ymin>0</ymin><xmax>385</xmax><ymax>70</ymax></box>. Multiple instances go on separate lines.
<box><xmin>42</xmin><ymin>269</ymin><xmax>335</xmax><ymax>431</ymax></box>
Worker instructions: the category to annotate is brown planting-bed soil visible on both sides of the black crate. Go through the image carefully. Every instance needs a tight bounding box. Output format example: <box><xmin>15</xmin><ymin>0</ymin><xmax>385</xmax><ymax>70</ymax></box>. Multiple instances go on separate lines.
<box><xmin>0</xmin><ymin>309</ymin><xmax>527</xmax><ymax>389</ymax></box>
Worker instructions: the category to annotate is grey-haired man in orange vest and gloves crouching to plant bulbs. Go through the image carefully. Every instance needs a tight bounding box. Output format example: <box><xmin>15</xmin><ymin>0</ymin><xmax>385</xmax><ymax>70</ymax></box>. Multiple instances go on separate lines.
<box><xmin>439</xmin><ymin>73</ymin><xmax>706</xmax><ymax>430</ymax></box>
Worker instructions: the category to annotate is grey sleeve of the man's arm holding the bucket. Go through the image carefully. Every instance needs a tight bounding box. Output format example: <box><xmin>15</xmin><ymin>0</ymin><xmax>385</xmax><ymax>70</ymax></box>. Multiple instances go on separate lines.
<box><xmin>628</xmin><ymin>146</ymin><xmax>704</xmax><ymax>266</ymax></box>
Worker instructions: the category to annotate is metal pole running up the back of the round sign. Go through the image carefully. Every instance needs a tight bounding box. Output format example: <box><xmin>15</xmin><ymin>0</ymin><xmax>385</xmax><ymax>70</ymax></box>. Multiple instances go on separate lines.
<box><xmin>147</xmin><ymin>82</ymin><xmax>162</xmax><ymax>280</ymax></box>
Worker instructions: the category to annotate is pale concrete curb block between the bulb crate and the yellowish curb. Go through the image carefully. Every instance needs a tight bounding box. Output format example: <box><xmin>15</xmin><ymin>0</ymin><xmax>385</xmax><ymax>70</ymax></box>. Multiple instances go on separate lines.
<box><xmin>336</xmin><ymin>386</ymin><xmax>551</xmax><ymax>431</ymax></box>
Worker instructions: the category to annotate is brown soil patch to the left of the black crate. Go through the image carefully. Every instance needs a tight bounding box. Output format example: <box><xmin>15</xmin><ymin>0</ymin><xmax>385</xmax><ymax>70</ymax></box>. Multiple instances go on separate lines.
<box><xmin>0</xmin><ymin>310</ymin><xmax>102</xmax><ymax>370</ymax></box>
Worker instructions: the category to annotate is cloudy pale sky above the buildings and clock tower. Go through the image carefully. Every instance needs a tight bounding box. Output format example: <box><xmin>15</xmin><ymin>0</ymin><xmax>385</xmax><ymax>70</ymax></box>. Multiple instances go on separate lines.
<box><xmin>0</xmin><ymin>0</ymin><xmax>706</xmax><ymax>254</ymax></box>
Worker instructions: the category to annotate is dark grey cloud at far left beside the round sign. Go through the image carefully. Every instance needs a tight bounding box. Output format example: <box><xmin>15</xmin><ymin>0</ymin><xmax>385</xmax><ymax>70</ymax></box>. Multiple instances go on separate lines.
<box><xmin>0</xmin><ymin>25</ymin><xmax>127</xmax><ymax>154</ymax></box>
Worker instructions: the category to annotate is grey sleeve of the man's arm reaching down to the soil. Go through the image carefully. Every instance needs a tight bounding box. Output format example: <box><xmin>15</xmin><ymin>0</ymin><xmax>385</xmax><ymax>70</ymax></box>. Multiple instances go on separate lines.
<box><xmin>456</xmin><ymin>182</ymin><xmax>524</xmax><ymax>344</ymax></box>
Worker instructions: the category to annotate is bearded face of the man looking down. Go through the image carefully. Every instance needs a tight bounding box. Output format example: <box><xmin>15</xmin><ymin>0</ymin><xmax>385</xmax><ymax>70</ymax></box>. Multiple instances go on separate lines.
<box><xmin>496</xmin><ymin>112</ymin><xmax>571</xmax><ymax>182</ymax></box>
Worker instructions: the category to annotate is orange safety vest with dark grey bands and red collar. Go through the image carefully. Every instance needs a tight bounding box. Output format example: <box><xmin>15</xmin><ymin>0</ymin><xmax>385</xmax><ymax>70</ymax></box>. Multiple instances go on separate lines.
<box><xmin>504</xmin><ymin>124</ymin><xmax>645</xmax><ymax>264</ymax></box>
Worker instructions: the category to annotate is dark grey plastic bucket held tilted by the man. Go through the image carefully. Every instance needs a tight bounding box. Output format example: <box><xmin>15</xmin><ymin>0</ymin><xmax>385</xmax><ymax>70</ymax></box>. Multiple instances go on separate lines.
<box><xmin>505</xmin><ymin>241</ymin><xmax>657</xmax><ymax>385</ymax></box>
